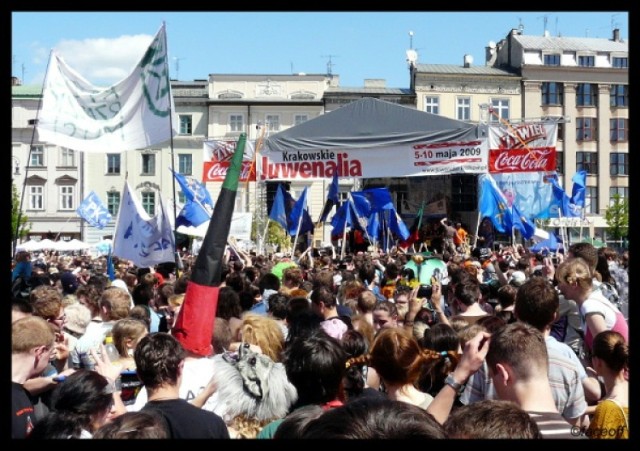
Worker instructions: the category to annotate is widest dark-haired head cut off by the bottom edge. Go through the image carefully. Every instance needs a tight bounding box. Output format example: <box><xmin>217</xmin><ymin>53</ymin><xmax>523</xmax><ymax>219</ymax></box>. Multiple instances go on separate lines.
<box><xmin>302</xmin><ymin>398</ymin><xmax>446</xmax><ymax>439</ymax></box>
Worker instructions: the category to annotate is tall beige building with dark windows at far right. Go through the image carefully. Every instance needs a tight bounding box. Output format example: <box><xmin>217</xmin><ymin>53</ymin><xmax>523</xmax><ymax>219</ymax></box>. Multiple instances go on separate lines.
<box><xmin>496</xmin><ymin>29</ymin><xmax>630</xmax><ymax>239</ymax></box>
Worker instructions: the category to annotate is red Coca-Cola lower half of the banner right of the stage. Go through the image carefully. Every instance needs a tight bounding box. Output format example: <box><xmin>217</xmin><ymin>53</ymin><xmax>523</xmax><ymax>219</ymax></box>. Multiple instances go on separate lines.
<box><xmin>489</xmin><ymin>147</ymin><xmax>556</xmax><ymax>172</ymax></box>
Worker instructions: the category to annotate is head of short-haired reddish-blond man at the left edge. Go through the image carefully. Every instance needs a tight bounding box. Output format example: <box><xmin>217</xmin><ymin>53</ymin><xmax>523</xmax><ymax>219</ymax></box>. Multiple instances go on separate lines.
<box><xmin>11</xmin><ymin>315</ymin><xmax>55</xmax><ymax>382</ymax></box>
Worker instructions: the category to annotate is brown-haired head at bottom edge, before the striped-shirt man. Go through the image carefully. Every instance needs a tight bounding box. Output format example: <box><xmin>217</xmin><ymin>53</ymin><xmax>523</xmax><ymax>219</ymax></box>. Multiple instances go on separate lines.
<box><xmin>443</xmin><ymin>399</ymin><xmax>542</xmax><ymax>439</ymax></box>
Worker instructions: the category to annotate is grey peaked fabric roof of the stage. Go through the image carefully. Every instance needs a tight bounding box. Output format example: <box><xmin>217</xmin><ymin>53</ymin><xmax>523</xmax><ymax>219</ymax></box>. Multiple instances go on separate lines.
<box><xmin>265</xmin><ymin>97</ymin><xmax>477</xmax><ymax>151</ymax></box>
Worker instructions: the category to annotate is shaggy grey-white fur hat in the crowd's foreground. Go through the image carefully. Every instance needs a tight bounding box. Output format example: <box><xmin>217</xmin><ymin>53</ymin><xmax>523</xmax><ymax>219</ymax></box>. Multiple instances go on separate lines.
<box><xmin>213</xmin><ymin>343</ymin><xmax>298</xmax><ymax>421</ymax></box>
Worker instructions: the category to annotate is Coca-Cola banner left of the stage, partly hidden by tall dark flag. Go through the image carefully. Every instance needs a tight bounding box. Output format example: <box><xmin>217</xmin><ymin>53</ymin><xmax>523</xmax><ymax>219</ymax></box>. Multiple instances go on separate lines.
<box><xmin>202</xmin><ymin>140</ymin><xmax>256</xmax><ymax>182</ymax></box>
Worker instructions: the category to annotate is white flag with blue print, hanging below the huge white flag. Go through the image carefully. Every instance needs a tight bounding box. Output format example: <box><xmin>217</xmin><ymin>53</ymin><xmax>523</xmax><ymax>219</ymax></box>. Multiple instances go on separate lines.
<box><xmin>113</xmin><ymin>182</ymin><xmax>175</xmax><ymax>268</ymax></box>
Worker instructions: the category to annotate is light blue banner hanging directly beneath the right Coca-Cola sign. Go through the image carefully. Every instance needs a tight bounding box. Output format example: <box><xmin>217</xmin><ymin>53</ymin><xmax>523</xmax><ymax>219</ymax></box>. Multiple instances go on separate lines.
<box><xmin>491</xmin><ymin>172</ymin><xmax>558</xmax><ymax>219</ymax></box>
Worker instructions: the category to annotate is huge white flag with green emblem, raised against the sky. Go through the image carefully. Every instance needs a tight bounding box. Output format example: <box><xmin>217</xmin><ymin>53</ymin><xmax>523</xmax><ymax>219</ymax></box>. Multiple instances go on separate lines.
<box><xmin>36</xmin><ymin>24</ymin><xmax>178</xmax><ymax>152</ymax></box>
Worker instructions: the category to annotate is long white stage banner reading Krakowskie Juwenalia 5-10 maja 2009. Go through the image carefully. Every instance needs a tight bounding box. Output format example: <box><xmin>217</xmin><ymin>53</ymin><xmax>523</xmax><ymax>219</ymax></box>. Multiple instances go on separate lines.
<box><xmin>258</xmin><ymin>138</ymin><xmax>489</xmax><ymax>180</ymax></box>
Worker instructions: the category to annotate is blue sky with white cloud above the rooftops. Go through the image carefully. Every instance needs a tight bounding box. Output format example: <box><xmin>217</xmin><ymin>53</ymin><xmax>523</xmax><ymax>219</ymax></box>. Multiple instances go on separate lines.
<box><xmin>11</xmin><ymin>11</ymin><xmax>629</xmax><ymax>88</ymax></box>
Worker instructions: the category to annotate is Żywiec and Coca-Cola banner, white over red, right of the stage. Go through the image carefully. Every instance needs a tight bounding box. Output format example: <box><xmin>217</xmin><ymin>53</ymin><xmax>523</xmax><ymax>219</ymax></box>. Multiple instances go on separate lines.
<box><xmin>489</xmin><ymin>122</ymin><xmax>558</xmax><ymax>174</ymax></box>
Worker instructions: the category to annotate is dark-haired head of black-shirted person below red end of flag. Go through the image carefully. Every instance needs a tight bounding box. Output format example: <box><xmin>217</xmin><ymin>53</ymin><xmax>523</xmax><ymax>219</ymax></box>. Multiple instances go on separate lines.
<box><xmin>133</xmin><ymin>332</ymin><xmax>186</xmax><ymax>390</ymax></box>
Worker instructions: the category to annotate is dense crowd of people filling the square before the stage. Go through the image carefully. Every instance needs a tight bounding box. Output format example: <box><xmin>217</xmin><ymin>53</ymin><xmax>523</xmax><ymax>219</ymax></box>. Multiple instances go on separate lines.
<box><xmin>11</xmin><ymin>228</ymin><xmax>630</xmax><ymax>440</ymax></box>
